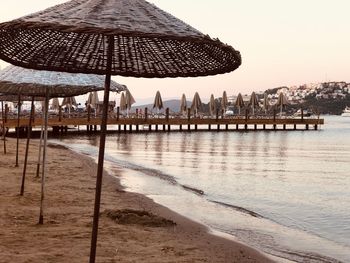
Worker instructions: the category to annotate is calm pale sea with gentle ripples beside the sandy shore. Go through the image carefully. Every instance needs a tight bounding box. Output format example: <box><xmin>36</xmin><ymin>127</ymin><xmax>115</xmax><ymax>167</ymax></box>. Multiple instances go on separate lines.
<box><xmin>55</xmin><ymin>116</ymin><xmax>350</xmax><ymax>262</ymax></box>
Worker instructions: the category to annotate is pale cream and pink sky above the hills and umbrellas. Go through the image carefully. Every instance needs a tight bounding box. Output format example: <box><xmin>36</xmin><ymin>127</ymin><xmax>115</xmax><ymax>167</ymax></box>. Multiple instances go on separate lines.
<box><xmin>0</xmin><ymin>0</ymin><xmax>350</xmax><ymax>100</ymax></box>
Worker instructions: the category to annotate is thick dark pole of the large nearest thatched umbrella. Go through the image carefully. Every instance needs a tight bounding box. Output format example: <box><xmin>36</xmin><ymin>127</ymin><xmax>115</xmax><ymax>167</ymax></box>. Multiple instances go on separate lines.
<box><xmin>89</xmin><ymin>36</ymin><xmax>114</xmax><ymax>263</ymax></box>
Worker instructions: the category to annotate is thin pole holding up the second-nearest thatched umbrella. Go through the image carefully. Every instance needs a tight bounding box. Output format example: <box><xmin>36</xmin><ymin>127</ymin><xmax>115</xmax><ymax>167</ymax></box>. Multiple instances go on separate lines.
<box><xmin>39</xmin><ymin>90</ymin><xmax>49</xmax><ymax>225</ymax></box>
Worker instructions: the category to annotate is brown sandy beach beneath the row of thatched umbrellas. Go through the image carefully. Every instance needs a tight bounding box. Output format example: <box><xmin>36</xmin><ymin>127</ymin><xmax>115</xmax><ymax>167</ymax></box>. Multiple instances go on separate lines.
<box><xmin>0</xmin><ymin>139</ymin><xmax>271</xmax><ymax>263</ymax></box>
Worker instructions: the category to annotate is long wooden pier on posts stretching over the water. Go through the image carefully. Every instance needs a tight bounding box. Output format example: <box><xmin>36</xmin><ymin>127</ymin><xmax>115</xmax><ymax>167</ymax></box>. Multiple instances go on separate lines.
<box><xmin>1</xmin><ymin>107</ymin><xmax>324</xmax><ymax>132</ymax></box>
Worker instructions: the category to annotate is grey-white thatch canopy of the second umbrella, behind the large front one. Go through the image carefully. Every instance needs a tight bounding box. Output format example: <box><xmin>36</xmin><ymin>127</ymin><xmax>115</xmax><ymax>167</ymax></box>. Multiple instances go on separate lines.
<box><xmin>0</xmin><ymin>66</ymin><xmax>126</xmax><ymax>98</ymax></box>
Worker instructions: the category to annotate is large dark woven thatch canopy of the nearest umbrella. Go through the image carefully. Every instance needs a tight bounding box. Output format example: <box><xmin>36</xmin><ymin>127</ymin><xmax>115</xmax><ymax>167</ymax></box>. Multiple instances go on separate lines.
<box><xmin>0</xmin><ymin>0</ymin><xmax>241</xmax><ymax>77</ymax></box>
